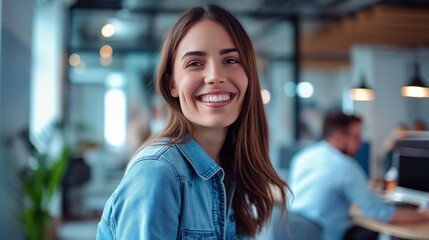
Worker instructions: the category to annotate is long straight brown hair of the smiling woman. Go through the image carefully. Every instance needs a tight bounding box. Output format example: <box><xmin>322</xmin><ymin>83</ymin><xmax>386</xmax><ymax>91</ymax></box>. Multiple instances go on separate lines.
<box><xmin>150</xmin><ymin>5</ymin><xmax>288</xmax><ymax>237</ymax></box>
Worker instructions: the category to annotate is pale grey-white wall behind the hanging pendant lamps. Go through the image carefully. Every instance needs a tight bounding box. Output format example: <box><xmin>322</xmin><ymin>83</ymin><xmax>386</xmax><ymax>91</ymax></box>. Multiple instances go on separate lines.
<box><xmin>352</xmin><ymin>46</ymin><xmax>429</xmax><ymax>177</ymax></box>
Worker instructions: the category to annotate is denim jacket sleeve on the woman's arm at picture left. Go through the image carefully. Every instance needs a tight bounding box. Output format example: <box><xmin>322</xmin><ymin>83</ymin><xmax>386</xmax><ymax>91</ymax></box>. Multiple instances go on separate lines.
<box><xmin>102</xmin><ymin>160</ymin><xmax>181</xmax><ymax>240</ymax></box>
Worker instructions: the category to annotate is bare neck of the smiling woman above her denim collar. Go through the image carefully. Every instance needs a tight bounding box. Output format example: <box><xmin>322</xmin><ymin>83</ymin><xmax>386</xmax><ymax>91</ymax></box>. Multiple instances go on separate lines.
<box><xmin>193</xmin><ymin>126</ymin><xmax>228</xmax><ymax>165</ymax></box>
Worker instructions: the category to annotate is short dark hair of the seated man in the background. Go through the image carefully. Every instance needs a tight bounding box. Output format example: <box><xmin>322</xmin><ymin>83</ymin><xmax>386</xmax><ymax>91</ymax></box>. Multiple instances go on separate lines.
<box><xmin>322</xmin><ymin>110</ymin><xmax>362</xmax><ymax>139</ymax></box>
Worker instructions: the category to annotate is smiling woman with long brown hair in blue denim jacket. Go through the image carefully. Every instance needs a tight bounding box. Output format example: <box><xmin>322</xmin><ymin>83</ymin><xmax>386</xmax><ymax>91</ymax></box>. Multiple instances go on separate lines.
<box><xmin>97</xmin><ymin>5</ymin><xmax>287</xmax><ymax>239</ymax></box>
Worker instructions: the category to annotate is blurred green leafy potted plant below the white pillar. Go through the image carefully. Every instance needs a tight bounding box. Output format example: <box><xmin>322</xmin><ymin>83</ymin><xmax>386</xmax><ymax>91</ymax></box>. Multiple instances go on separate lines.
<box><xmin>18</xmin><ymin>123</ymin><xmax>70</xmax><ymax>240</ymax></box>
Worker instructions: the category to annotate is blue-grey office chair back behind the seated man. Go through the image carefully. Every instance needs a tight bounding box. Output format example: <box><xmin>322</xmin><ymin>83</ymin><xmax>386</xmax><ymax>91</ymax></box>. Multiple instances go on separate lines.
<box><xmin>271</xmin><ymin>207</ymin><xmax>322</xmax><ymax>240</ymax></box>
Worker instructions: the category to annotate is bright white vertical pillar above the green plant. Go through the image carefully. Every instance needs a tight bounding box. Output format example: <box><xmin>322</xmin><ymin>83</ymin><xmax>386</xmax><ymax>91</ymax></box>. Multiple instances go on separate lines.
<box><xmin>30</xmin><ymin>1</ymin><xmax>67</xmax><ymax>135</ymax></box>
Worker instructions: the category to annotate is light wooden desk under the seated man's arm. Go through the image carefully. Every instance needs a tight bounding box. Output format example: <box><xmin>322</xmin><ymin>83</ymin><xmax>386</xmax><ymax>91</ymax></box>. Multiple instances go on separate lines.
<box><xmin>350</xmin><ymin>207</ymin><xmax>429</xmax><ymax>240</ymax></box>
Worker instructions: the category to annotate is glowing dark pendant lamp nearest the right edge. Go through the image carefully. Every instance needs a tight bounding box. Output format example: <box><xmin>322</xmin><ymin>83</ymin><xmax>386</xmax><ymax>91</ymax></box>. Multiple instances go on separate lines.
<box><xmin>401</xmin><ymin>63</ymin><xmax>429</xmax><ymax>98</ymax></box>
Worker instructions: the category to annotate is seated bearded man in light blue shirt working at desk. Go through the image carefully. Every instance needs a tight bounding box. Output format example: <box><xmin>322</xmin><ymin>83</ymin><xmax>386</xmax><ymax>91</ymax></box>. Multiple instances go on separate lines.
<box><xmin>289</xmin><ymin>111</ymin><xmax>429</xmax><ymax>240</ymax></box>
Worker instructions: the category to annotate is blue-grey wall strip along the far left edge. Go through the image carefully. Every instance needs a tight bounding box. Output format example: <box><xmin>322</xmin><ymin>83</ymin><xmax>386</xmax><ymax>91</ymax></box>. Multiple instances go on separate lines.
<box><xmin>0</xmin><ymin>0</ymin><xmax>33</xmax><ymax>239</ymax></box>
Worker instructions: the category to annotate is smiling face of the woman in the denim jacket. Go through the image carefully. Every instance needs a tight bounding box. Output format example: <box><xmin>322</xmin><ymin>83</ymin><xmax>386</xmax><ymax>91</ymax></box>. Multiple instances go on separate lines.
<box><xmin>170</xmin><ymin>19</ymin><xmax>248</xmax><ymax>131</ymax></box>
